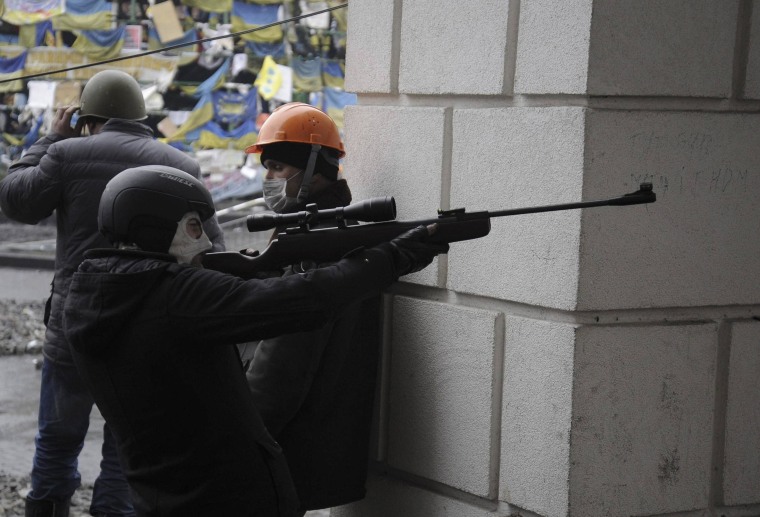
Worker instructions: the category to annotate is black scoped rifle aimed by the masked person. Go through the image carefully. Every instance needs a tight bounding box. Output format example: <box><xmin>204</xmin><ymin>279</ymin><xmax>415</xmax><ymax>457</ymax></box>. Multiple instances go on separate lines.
<box><xmin>203</xmin><ymin>183</ymin><xmax>657</xmax><ymax>278</ymax></box>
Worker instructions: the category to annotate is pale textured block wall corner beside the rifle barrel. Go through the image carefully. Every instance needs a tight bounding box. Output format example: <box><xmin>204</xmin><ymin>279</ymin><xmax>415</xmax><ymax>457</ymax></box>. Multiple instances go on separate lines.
<box><xmin>340</xmin><ymin>0</ymin><xmax>760</xmax><ymax>517</ymax></box>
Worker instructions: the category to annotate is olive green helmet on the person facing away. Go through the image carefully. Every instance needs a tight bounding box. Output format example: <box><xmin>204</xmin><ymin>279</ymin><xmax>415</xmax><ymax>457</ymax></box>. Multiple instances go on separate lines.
<box><xmin>79</xmin><ymin>70</ymin><xmax>148</xmax><ymax>120</ymax></box>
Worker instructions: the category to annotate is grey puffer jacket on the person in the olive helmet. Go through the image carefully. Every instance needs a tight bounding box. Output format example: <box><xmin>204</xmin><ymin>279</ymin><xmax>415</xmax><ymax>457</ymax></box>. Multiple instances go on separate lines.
<box><xmin>0</xmin><ymin>119</ymin><xmax>224</xmax><ymax>362</ymax></box>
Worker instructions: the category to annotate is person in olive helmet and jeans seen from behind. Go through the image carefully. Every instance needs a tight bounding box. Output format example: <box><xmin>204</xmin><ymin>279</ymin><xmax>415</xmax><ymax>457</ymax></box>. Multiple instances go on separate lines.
<box><xmin>0</xmin><ymin>70</ymin><xmax>224</xmax><ymax>517</ymax></box>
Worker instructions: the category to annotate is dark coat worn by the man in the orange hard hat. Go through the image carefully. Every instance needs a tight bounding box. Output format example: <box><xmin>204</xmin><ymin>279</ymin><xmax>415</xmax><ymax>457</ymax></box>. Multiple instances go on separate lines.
<box><xmin>246</xmin><ymin>181</ymin><xmax>380</xmax><ymax>510</ymax></box>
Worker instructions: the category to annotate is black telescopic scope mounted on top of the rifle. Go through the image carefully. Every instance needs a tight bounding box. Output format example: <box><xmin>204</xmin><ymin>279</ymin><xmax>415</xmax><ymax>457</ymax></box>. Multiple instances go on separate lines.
<box><xmin>246</xmin><ymin>196</ymin><xmax>396</xmax><ymax>232</ymax></box>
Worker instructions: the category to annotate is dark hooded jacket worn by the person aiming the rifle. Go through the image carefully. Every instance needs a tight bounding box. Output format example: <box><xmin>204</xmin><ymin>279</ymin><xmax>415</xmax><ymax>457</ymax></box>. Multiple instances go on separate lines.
<box><xmin>60</xmin><ymin>244</ymin><xmax>396</xmax><ymax>517</ymax></box>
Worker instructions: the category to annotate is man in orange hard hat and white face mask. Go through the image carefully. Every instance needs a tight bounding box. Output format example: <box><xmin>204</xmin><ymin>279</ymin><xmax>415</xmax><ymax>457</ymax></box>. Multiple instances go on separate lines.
<box><xmin>242</xmin><ymin>103</ymin><xmax>380</xmax><ymax>512</ymax></box>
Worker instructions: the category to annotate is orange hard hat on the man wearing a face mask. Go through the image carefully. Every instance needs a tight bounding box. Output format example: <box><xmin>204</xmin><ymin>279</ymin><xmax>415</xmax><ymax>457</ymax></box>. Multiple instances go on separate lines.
<box><xmin>245</xmin><ymin>102</ymin><xmax>346</xmax><ymax>158</ymax></box>
